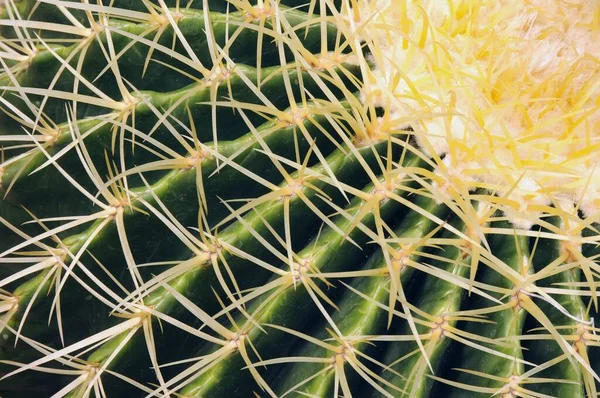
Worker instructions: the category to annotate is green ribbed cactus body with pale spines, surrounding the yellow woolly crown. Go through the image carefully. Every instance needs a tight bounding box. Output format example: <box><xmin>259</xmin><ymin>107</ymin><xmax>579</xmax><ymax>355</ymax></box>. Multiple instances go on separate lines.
<box><xmin>0</xmin><ymin>0</ymin><xmax>598</xmax><ymax>396</ymax></box>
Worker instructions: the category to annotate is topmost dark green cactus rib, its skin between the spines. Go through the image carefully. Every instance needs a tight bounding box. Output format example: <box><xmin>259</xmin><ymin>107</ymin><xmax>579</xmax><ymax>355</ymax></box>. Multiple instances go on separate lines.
<box><xmin>0</xmin><ymin>5</ymin><xmax>337</xmax><ymax>116</ymax></box>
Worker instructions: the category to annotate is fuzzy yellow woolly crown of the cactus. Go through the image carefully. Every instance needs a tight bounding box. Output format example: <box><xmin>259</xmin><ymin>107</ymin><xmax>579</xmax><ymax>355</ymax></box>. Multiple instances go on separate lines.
<box><xmin>347</xmin><ymin>0</ymin><xmax>600</xmax><ymax>227</ymax></box>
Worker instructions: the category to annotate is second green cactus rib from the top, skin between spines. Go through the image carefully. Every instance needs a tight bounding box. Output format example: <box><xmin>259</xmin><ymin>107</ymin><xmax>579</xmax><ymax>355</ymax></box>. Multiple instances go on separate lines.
<box><xmin>2</xmin><ymin>60</ymin><xmax>356</xmax><ymax>171</ymax></box>
